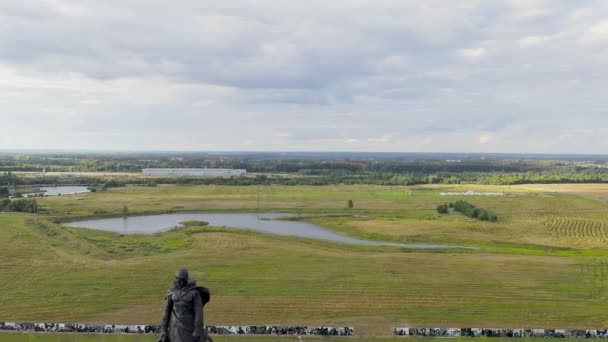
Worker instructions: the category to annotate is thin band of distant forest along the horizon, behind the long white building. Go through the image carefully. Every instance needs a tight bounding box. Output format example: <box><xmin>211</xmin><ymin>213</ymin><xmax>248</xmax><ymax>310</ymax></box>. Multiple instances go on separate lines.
<box><xmin>0</xmin><ymin>153</ymin><xmax>606</xmax><ymax>175</ymax></box>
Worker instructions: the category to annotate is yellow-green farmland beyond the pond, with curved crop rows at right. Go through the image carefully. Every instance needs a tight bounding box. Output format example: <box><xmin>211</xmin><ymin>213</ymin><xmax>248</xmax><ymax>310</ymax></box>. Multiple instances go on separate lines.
<box><xmin>41</xmin><ymin>185</ymin><xmax>608</xmax><ymax>249</ymax></box>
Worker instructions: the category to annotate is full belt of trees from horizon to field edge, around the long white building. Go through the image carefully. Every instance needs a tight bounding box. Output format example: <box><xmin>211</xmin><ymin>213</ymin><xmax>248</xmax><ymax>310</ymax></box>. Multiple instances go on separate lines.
<box><xmin>0</xmin><ymin>152</ymin><xmax>608</xmax><ymax>188</ymax></box>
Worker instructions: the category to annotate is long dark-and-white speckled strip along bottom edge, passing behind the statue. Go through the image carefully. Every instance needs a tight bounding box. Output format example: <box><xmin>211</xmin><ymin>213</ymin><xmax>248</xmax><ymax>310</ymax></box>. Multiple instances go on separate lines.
<box><xmin>0</xmin><ymin>322</ymin><xmax>354</xmax><ymax>336</ymax></box>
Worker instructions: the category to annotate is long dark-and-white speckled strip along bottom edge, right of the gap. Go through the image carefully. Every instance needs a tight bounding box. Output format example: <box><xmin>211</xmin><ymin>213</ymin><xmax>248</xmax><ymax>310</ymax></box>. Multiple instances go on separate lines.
<box><xmin>394</xmin><ymin>328</ymin><xmax>608</xmax><ymax>338</ymax></box>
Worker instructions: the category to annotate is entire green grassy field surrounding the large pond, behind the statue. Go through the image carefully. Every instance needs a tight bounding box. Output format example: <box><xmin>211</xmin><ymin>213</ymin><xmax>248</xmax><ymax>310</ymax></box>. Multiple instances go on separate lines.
<box><xmin>0</xmin><ymin>185</ymin><xmax>608</xmax><ymax>341</ymax></box>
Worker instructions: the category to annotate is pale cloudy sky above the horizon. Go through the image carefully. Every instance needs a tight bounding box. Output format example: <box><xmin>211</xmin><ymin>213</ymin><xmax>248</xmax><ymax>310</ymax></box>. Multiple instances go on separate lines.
<box><xmin>0</xmin><ymin>0</ymin><xmax>608</xmax><ymax>154</ymax></box>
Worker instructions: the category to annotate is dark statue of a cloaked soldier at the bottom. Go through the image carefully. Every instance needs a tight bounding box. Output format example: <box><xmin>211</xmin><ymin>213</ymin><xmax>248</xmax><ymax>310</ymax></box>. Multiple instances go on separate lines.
<box><xmin>159</xmin><ymin>268</ymin><xmax>213</xmax><ymax>342</ymax></box>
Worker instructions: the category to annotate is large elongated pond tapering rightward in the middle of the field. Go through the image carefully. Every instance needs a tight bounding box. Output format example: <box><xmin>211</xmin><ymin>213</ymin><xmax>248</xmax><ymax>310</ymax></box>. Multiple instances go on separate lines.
<box><xmin>64</xmin><ymin>213</ymin><xmax>474</xmax><ymax>249</ymax></box>
